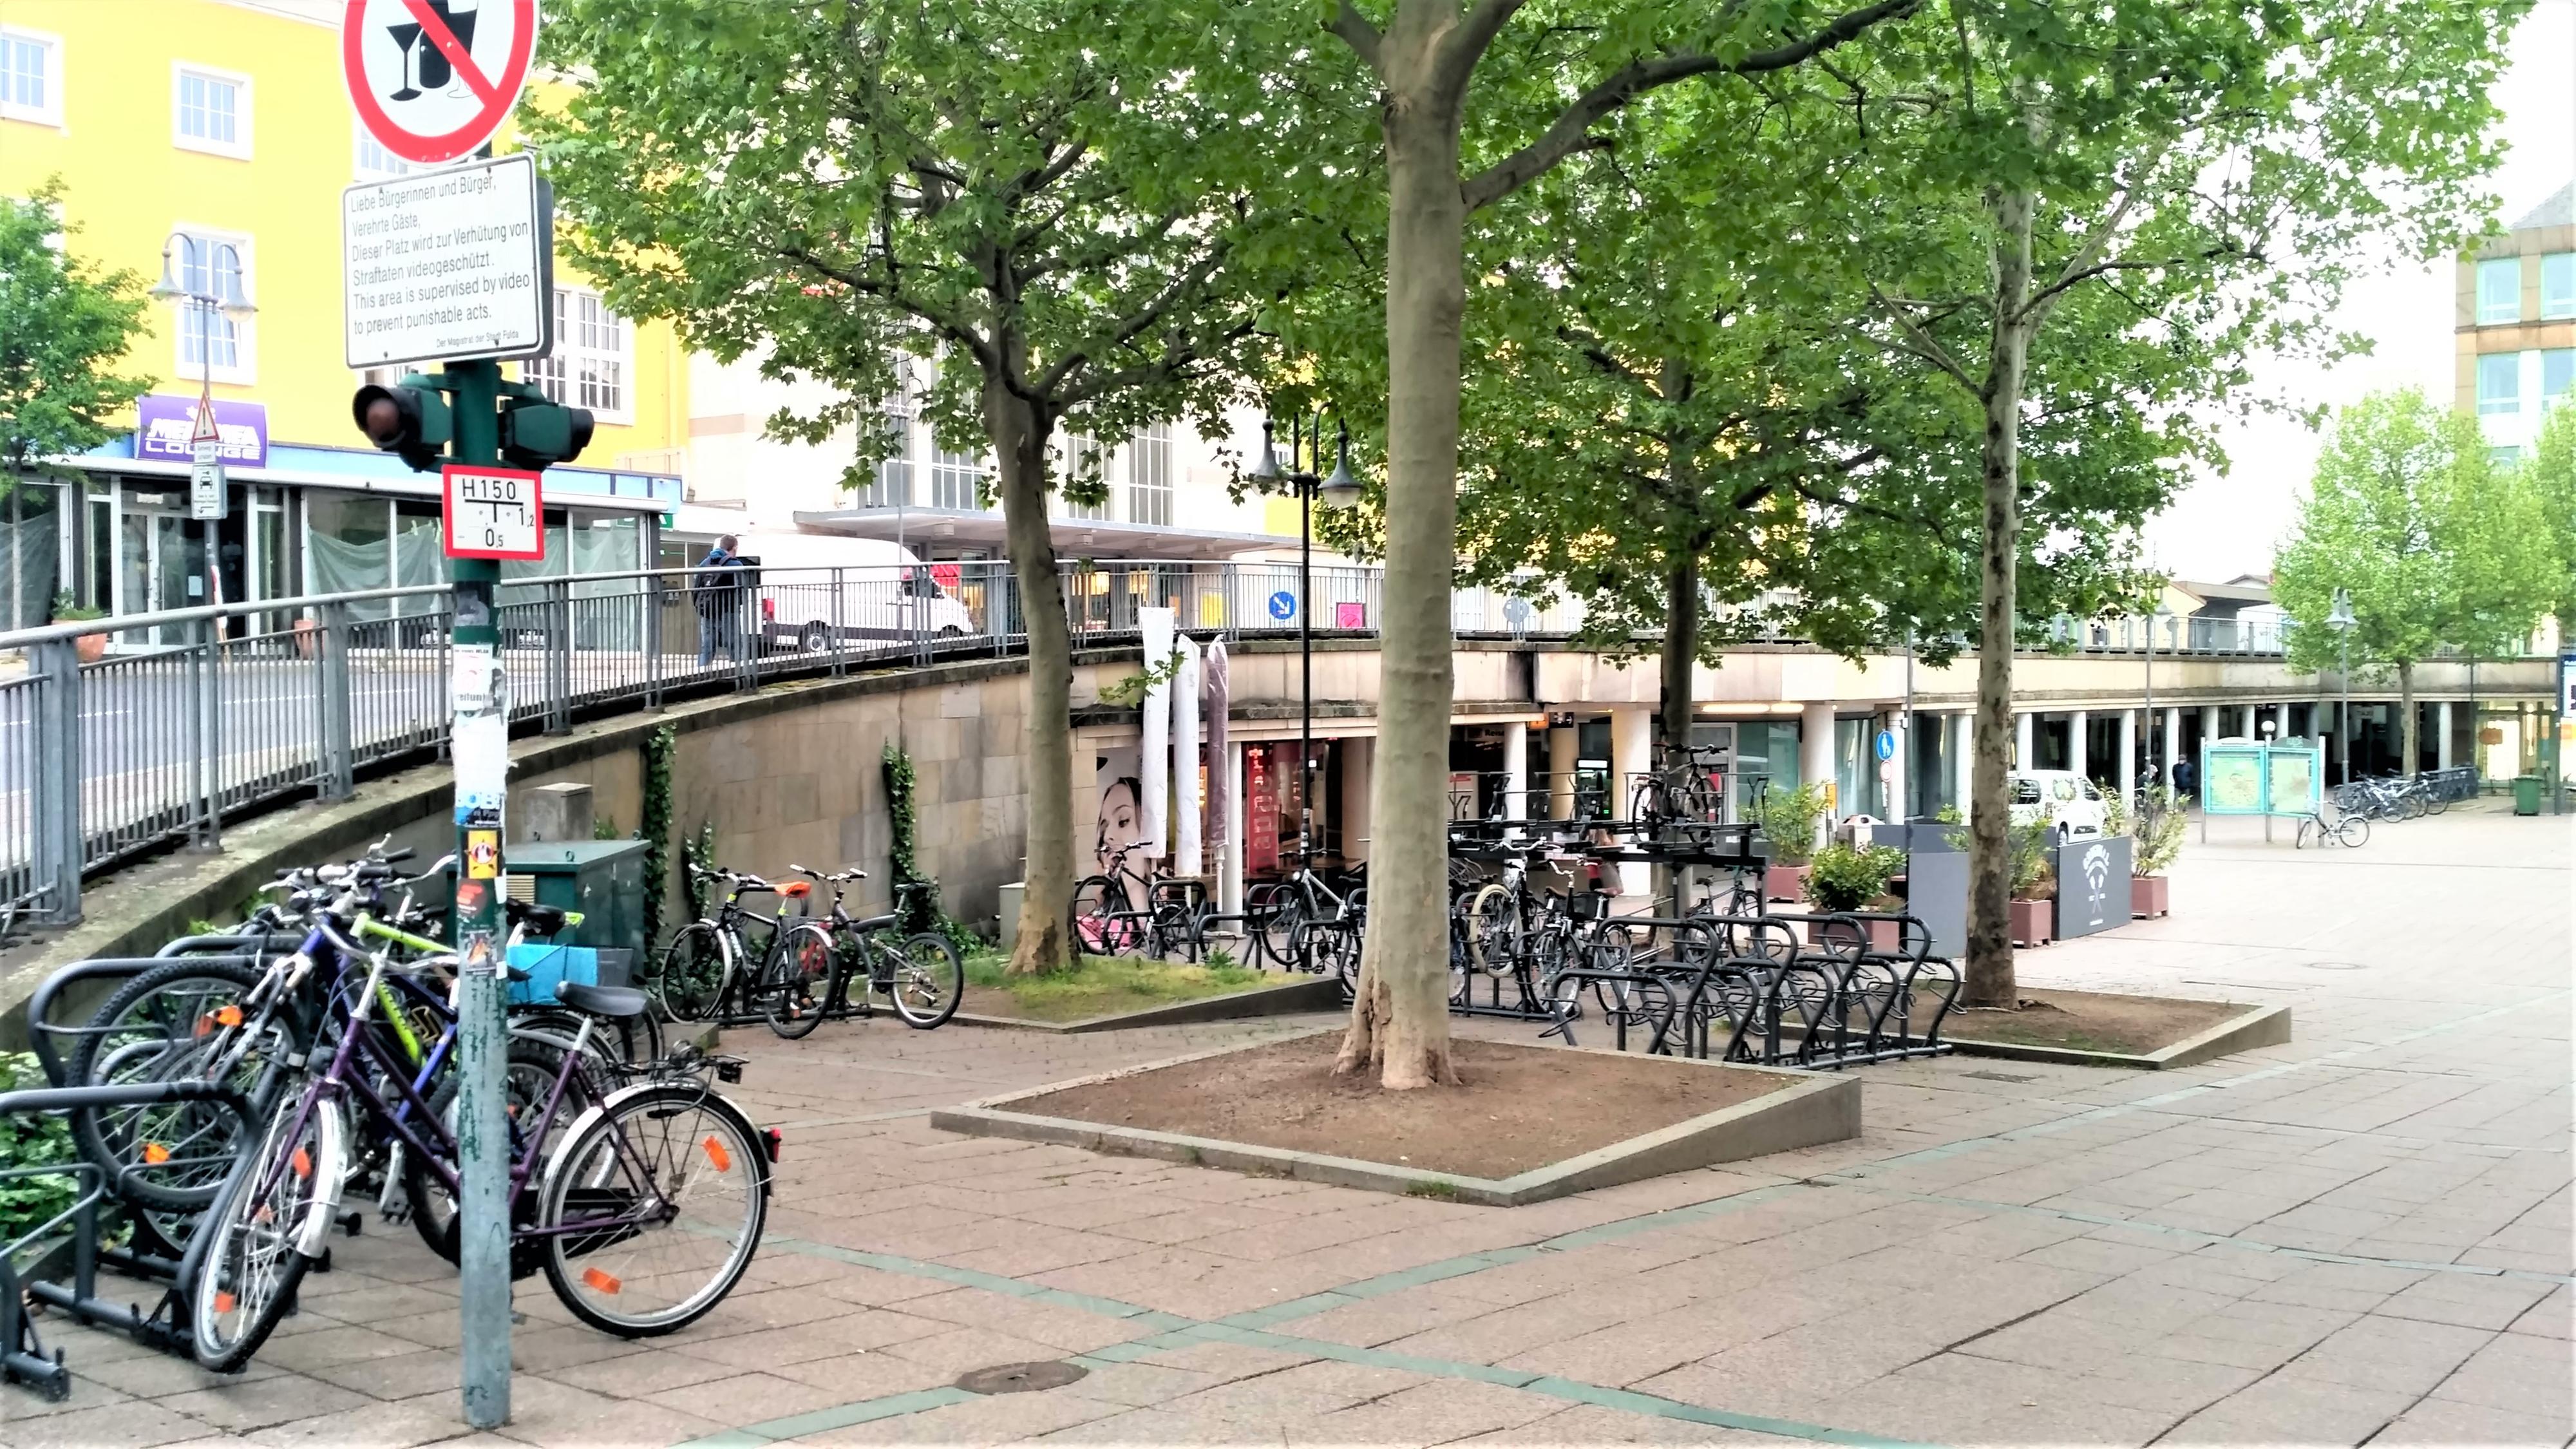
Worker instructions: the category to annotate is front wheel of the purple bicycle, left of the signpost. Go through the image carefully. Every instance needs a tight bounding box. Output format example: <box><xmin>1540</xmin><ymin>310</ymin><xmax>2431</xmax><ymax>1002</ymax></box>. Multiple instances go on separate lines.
<box><xmin>188</xmin><ymin>1099</ymin><xmax>340</xmax><ymax>1374</ymax></box>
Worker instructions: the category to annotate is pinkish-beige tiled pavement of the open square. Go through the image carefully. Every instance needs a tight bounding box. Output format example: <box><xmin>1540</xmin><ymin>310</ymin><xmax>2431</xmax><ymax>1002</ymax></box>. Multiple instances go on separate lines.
<box><xmin>0</xmin><ymin>810</ymin><xmax>2576</xmax><ymax>1449</ymax></box>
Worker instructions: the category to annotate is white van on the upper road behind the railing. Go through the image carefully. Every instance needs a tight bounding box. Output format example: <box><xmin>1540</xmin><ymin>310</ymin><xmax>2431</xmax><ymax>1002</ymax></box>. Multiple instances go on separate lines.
<box><xmin>716</xmin><ymin>534</ymin><xmax>976</xmax><ymax>652</ymax></box>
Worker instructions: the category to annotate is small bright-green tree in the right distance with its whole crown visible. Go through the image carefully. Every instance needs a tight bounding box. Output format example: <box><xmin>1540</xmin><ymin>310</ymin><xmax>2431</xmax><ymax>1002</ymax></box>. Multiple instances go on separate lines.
<box><xmin>2272</xmin><ymin>392</ymin><xmax>2550</xmax><ymax>773</ymax></box>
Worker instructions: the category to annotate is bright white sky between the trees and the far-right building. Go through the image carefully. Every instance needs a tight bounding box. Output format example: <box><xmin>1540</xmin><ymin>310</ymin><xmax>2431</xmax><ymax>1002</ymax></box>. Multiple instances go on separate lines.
<box><xmin>2146</xmin><ymin>0</ymin><xmax>2576</xmax><ymax>583</ymax></box>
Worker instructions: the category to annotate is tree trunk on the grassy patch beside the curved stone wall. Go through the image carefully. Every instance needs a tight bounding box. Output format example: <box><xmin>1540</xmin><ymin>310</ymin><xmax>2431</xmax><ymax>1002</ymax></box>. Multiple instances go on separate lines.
<box><xmin>984</xmin><ymin>379</ymin><xmax>1074</xmax><ymax>974</ymax></box>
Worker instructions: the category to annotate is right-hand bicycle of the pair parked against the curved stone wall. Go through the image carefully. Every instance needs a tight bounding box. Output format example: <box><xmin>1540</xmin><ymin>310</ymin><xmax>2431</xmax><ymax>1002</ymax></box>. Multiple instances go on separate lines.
<box><xmin>760</xmin><ymin>864</ymin><xmax>966</xmax><ymax>1039</ymax></box>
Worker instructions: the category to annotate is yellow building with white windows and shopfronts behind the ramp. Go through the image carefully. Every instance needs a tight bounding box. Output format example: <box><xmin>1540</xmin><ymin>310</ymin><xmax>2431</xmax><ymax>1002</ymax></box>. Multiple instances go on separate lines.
<box><xmin>0</xmin><ymin>0</ymin><xmax>688</xmax><ymax>627</ymax></box>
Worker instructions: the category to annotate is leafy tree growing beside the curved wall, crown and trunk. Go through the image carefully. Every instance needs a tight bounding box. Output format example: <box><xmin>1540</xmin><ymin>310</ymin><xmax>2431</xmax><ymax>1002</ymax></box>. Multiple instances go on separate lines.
<box><xmin>526</xmin><ymin>0</ymin><xmax>1358</xmax><ymax>972</ymax></box>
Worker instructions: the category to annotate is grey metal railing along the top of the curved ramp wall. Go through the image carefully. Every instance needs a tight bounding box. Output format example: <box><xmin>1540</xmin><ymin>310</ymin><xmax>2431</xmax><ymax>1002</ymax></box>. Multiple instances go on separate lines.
<box><xmin>0</xmin><ymin>560</ymin><xmax>2370</xmax><ymax>923</ymax></box>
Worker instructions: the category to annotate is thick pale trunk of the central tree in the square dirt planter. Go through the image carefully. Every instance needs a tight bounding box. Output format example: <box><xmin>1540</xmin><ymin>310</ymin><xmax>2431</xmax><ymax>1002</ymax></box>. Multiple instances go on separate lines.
<box><xmin>1334</xmin><ymin>68</ymin><xmax>1466</xmax><ymax>1088</ymax></box>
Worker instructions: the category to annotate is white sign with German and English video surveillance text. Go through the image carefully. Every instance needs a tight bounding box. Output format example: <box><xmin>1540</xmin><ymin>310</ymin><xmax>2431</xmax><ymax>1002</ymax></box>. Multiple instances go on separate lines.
<box><xmin>340</xmin><ymin>155</ymin><xmax>554</xmax><ymax>372</ymax></box>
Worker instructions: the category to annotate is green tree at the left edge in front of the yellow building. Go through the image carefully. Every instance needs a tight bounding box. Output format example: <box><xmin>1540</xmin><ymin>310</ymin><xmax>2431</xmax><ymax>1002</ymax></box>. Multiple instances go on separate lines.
<box><xmin>0</xmin><ymin>183</ymin><xmax>152</xmax><ymax>477</ymax></box>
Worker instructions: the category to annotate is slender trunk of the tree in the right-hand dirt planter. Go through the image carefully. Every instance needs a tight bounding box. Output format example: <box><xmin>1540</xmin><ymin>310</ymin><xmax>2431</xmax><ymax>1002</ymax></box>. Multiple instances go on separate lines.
<box><xmin>1963</xmin><ymin>191</ymin><xmax>2032</xmax><ymax>1010</ymax></box>
